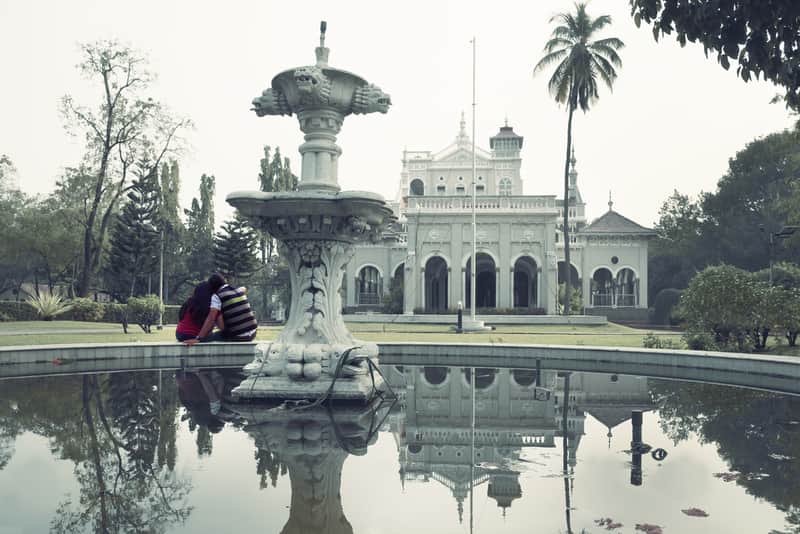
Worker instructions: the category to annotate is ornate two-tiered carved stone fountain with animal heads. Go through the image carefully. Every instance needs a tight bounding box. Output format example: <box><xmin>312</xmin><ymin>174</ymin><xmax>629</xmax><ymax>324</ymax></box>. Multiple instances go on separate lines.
<box><xmin>227</xmin><ymin>22</ymin><xmax>394</xmax><ymax>400</ymax></box>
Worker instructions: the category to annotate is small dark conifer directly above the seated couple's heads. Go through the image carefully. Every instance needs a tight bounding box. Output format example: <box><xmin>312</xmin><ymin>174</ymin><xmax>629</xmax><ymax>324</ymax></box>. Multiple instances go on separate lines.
<box><xmin>214</xmin><ymin>217</ymin><xmax>259</xmax><ymax>285</ymax></box>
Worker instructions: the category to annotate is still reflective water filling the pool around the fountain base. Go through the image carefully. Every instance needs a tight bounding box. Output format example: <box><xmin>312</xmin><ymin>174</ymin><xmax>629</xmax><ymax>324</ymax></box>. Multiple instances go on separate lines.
<box><xmin>0</xmin><ymin>366</ymin><xmax>800</xmax><ymax>534</ymax></box>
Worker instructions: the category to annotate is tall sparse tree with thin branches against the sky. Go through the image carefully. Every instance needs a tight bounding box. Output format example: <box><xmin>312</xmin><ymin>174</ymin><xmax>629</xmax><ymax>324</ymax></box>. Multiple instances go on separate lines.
<box><xmin>62</xmin><ymin>41</ymin><xmax>188</xmax><ymax>296</ymax></box>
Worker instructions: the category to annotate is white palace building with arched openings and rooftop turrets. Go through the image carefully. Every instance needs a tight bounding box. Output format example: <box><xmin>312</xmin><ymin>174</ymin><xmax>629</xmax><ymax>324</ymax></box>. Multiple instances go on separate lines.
<box><xmin>344</xmin><ymin>115</ymin><xmax>654</xmax><ymax>320</ymax></box>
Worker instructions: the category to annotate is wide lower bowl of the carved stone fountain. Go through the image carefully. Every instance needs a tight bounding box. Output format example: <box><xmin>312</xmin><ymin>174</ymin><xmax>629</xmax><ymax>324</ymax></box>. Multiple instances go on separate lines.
<box><xmin>226</xmin><ymin>190</ymin><xmax>395</xmax><ymax>243</ymax></box>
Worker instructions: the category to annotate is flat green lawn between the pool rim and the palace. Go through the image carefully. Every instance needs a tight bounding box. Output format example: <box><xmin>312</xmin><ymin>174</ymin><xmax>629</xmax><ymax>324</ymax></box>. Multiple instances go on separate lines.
<box><xmin>0</xmin><ymin>321</ymin><xmax>800</xmax><ymax>356</ymax></box>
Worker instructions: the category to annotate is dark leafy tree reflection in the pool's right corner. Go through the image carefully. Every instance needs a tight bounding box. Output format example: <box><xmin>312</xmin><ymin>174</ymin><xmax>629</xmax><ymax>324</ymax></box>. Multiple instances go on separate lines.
<box><xmin>651</xmin><ymin>381</ymin><xmax>800</xmax><ymax>534</ymax></box>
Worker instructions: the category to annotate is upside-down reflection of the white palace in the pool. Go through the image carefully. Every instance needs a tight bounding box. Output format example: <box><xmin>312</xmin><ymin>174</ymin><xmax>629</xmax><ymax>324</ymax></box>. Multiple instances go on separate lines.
<box><xmin>387</xmin><ymin>366</ymin><xmax>654</xmax><ymax>521</ymax></box>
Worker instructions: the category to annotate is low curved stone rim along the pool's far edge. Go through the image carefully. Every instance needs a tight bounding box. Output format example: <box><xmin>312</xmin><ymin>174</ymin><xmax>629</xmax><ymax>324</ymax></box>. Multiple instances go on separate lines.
<box><xmin>0</xmin><ymin>341</ymin><xmax>800</xmax><ymax>395</ymax></box>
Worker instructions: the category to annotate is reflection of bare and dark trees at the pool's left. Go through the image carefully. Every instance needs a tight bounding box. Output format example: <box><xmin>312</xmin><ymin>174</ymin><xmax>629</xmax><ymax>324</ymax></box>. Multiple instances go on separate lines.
<box><xmin>0</xmin><ymin>372</ymin><xmax>191</xmax><ymax>534</ymax></box>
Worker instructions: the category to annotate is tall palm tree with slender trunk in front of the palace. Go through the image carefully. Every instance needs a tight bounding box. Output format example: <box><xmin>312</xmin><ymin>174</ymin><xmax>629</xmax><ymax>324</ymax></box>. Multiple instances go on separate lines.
<box><xmin>533</xmin><ymin>3</ymin><xmax>625</xmax><ymax>315</ymax></box>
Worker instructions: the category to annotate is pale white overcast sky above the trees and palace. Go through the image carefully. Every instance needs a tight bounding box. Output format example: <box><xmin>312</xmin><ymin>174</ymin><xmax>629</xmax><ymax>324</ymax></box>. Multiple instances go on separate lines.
<box><xmin>0</xmin><ymin>0</ymin><xmax>791</xmax><ymax>225</ymax></box>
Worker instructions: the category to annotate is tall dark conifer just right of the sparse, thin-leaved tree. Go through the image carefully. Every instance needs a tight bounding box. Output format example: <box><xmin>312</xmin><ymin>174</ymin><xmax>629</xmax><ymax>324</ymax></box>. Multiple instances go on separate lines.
<box><xmin>108</xmin><ymin>161</ymin><xmax>159</xmax><ymax>297</ymax></box>
